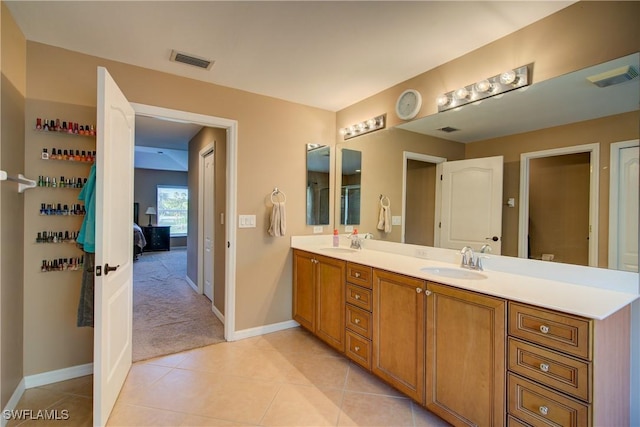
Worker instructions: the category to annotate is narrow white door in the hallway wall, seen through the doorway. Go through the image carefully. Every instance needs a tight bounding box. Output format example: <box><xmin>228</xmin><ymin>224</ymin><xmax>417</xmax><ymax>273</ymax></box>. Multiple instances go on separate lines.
<box><xmin>202</xmin><ymin>151</ymin><xmax>215</xmax><ymax>302</ymax></box>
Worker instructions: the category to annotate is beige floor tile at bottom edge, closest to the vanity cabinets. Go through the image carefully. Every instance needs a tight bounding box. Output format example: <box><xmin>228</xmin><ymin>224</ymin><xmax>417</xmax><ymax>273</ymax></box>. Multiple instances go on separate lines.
<box><xmin>338</xmin><ymin>391</ymin><xmax>413</xmax><ymax>427</ymax></box>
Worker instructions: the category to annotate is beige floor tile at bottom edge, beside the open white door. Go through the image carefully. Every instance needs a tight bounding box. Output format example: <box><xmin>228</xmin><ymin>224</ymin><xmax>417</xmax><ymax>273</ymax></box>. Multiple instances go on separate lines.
<box><xmin>107</xmin><ymin>403</ymin><xmax>185</xmax><ymax>427</ymax></box>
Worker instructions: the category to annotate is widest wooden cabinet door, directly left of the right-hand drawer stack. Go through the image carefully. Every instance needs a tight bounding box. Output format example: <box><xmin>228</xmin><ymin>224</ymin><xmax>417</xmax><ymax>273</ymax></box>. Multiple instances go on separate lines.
<box><xmin>426</xmin><ymin>282</ymin><xmax>506</xmax><ymax>426</ymax></box>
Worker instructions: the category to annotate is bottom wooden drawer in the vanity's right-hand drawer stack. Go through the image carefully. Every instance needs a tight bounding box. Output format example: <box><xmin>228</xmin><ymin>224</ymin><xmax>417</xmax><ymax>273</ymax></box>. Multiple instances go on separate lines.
<box><xmin>508</xmin><ymin>374</ymin><xmax>591</xmax><ymax>427</ymax></box>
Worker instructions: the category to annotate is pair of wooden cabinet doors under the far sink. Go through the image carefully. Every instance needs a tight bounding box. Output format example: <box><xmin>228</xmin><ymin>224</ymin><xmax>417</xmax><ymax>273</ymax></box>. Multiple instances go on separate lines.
<box><xmin>293</xmin><ymin>250</ymin><xmax>346</xmax><ymax>352</ymax></box>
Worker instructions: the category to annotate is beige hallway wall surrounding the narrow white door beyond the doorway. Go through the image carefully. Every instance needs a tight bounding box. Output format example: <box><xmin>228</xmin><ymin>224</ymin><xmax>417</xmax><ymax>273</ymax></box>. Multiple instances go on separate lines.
<box><xmin>187</xmin><ymin>128</ymin><xmax>227</xmax><ymax>315</ymax></box>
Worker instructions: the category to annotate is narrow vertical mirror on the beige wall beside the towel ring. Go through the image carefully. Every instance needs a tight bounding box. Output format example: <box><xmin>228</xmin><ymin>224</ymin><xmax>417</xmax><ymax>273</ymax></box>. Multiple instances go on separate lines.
<box><xmin>306</xmin><ymin>144</ymin><xmax>331</xmax><ymax>225</ymax></box>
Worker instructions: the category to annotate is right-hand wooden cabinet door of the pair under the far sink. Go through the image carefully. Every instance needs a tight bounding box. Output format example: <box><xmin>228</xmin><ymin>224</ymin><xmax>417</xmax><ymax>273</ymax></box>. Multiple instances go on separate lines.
<box><xmin>315</xmin><ymin>256</ymin><xmax>346</xmax><ymax>352</ymax></box>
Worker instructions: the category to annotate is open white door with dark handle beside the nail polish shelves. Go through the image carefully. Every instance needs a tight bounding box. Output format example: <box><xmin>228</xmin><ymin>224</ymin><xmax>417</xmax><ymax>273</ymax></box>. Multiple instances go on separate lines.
<box><xmin>93</xmin><ymin>67</ymin><xmax>135</xmax><ymax>426</ymax></box>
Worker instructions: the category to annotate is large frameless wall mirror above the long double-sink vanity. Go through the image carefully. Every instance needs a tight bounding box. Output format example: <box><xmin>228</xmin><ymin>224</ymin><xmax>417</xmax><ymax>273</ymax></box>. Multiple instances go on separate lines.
<box><xmin>336</xmin><ymin>53</ymin><xmax>640</xmax><ymax>271</ymax></box>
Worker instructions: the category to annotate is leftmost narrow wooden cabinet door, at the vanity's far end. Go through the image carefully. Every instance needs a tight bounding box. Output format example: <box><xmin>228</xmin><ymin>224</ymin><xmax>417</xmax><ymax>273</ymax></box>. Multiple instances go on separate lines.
<box><xmin>293</xmin><ymin>250</ymin><xmax>316</xmax><ymax>332</ymax></box>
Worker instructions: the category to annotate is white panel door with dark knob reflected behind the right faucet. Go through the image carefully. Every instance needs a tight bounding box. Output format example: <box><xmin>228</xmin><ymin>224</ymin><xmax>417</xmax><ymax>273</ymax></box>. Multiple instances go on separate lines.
<box><xmin>440</xmin><ymin>156</ymin><xmax>503</xmax><ymax>255</ymax></box>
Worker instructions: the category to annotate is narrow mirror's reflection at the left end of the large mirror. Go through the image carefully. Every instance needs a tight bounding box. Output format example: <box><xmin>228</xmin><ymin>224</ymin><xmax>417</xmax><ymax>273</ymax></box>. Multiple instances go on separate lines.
<box><xmin>336</xmin><ymin>148</ymin><xmax>362</xmax><ymax>225</ymax></box>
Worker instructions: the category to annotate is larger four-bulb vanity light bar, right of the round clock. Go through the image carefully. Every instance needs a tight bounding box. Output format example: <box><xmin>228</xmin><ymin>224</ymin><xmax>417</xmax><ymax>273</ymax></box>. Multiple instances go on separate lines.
<box><xmin>436</xmin><ymin>64</ymin><xmax>532</xmax><ymax>112</ymax></box>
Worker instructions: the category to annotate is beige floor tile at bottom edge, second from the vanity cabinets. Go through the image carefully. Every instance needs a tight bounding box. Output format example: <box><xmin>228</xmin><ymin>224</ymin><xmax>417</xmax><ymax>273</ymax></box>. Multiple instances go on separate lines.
<box><xmin>261</xmin><ymin>384</ymin><xmax>343</xmax><ymax>426</ymax></box>
